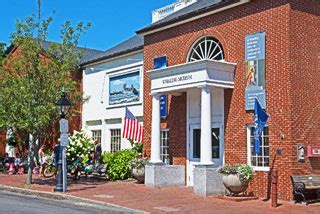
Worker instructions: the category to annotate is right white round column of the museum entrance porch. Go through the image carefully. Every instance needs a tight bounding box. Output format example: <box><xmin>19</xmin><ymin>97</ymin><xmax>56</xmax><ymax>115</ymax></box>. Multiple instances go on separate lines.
<box><xmin>200</xmin><ymin>86</ymin><xmax>213</xmax><ymax>165</ymax></box>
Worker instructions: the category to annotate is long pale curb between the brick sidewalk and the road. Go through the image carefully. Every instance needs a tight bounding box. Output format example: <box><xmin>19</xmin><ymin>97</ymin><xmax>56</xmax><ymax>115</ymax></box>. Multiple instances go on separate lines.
<box><xmin>0</xmin><ymin>184</ymin><xmax>148</xmax><ymax>213</ymax></box>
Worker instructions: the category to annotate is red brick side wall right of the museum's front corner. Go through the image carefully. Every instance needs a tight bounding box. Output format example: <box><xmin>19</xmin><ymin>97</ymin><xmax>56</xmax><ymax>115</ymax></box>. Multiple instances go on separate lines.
<box><xmin>290</xmin><ymin>0</ymin><xmax>320</xmax><ymax>174</ymax></box>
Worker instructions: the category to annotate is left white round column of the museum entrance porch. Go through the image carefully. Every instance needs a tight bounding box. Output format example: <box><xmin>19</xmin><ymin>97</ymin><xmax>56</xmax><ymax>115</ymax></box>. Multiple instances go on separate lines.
<box><xmin>150</xmin><ymin>94</ymin><xmax>162</xmax><ymax>163</ymax></box>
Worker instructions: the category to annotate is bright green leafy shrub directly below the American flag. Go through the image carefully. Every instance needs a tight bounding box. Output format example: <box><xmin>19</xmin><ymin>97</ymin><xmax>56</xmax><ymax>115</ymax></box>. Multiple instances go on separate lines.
<box><xmin>101</xmin><ymin>150</ymin><xmax>136</xmax><ymax>180</ymax></box>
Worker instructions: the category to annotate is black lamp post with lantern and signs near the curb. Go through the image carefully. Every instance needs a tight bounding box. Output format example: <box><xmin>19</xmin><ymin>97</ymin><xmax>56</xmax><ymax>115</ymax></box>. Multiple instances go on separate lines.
<box><xmin>54</xmin><ymin>88</ymin><xmax>71</xmax><ymax>192</ymax></box>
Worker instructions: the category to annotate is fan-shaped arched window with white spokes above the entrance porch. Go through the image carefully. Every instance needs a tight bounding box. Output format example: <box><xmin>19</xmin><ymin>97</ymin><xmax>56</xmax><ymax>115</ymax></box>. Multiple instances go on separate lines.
<box><xmin>188</xmin><ymin>36</ymin><xmax>224</xmax><ymax>62</ymax></box>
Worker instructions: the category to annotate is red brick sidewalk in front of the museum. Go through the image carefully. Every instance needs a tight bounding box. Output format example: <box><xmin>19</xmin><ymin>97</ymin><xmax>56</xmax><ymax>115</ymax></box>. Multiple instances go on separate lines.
<box><xmin>0</xmin><ymin>175</ymin><xmax>320</xmax><ymax>214</ymax></box>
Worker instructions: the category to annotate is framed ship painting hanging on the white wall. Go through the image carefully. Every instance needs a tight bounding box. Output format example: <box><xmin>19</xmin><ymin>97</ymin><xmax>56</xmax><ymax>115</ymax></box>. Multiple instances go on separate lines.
<box><xmin>109</xmin><ymin>72</ymin><xmax>140</xmax><ymax>105</ymax></box>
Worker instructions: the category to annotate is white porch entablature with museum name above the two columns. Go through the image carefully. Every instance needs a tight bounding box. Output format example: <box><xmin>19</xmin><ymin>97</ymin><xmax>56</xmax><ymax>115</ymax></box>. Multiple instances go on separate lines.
<box><xmin>147</xmin><ymin>60</ymin><xmax>236</xmax><ymax>93</ymax></box>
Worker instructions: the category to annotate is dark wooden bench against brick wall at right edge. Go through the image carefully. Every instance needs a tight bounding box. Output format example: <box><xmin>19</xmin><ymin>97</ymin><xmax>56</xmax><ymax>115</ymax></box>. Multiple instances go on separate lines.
<box><xmin>290</xmin><ymin>175</ymin><xmax>320</xmax><ymax>205</ymax></box>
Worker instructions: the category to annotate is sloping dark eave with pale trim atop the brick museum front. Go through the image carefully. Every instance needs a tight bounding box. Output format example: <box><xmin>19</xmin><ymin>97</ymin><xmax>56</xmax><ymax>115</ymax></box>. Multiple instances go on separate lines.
<box><xmin>136</xmin><ymin>0</ymin><xmax>251</xmax><ymax>36</ymax></box>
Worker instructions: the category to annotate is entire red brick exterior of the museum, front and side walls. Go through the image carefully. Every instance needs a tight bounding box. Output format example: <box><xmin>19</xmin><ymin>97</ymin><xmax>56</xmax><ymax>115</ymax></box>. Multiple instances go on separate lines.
<box><xmin>144</xmin><ymin>0</ymin><xmax>320</xmax><ymax>200</ymax></box>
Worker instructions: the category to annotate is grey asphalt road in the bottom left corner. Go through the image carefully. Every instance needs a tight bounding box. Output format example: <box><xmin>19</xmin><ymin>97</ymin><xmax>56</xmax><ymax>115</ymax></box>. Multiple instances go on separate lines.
<box><xmin>0</xmin><ymin>191</ymin><xmax>136</xmax><ymax>214</ymax></box>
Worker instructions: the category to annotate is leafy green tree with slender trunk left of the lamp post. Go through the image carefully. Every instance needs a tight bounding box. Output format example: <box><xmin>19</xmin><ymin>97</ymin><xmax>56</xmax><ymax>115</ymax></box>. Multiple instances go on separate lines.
<box><xmin>0</xmin><ymin>12</ymin><xmax>89</xmax><ymax>184</ymax></box>
